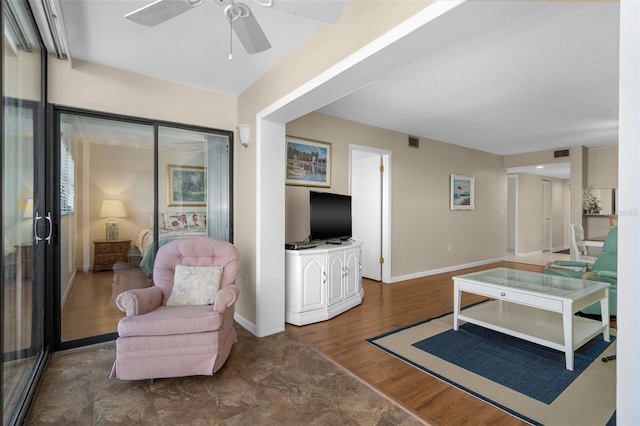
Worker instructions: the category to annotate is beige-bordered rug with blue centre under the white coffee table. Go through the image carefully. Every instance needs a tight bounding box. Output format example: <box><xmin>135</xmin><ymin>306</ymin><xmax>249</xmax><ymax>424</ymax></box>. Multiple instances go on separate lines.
<box><xmin>367</xmin><ymin>314</ymin><xmax>616</xmax><ymax>425</ymax></box>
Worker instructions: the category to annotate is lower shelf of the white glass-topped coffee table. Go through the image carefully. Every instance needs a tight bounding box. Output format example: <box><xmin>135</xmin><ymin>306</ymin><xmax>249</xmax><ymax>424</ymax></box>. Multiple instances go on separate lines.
<box><xmin>458</xmin><ymin>300</ymin><xmax>606</xmax><ymax>369</ymax></box>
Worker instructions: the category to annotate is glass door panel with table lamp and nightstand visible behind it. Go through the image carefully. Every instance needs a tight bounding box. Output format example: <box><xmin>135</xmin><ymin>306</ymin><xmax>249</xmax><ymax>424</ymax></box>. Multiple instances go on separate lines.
<box><xmin>60</xmin><ymin>113</ymin><xmax>154</xmax><ymax>342</ymax></box>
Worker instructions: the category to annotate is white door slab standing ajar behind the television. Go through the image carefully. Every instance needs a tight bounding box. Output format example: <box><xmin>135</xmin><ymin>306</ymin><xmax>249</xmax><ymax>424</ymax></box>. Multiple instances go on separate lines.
<box><xmin>351</xmin><ymin>151</ymin><xmax>382</xmax><ymax>281</ymax></box>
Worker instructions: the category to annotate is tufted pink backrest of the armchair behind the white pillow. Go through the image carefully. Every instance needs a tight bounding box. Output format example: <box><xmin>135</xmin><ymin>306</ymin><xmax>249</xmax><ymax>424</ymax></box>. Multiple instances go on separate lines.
<box><xmin>153</xmin><ymin>237</ymin><xmax>239</xmax><ymax>305</ymax></box>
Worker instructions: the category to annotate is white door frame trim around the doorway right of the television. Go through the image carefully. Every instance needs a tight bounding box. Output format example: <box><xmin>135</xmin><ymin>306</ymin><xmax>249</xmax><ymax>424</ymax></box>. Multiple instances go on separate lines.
<box><xmin>349</xmin><ymin>144</ymin><xmax>392</xmax><ymax>284</ymax></box>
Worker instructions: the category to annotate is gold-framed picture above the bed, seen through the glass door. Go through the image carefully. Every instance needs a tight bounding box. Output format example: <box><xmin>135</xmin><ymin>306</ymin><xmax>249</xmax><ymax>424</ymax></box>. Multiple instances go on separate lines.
<box><xmin>167</xmin><ymin>164</ymin><xmax>207</xmax><ymax>206</ymax></box>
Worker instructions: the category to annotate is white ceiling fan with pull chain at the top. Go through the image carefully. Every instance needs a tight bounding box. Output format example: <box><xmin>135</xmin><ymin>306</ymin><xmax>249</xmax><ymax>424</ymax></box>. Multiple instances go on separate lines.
<box><xmin>125</xmin><ymin>0</ymin><xmax>344</xmax><ymax>60</ymax></box>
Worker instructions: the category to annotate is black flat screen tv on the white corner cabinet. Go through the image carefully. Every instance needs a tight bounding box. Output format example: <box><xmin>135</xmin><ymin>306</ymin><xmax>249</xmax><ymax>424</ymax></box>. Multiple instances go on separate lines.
<box><xmin>309</xmin><ymin>191</ymin><xmax>352</xmax><ymax>241</ymax></box>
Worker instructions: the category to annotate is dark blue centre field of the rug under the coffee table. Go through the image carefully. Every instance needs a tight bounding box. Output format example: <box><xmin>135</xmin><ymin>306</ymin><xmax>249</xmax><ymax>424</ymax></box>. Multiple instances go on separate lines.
<box><xmin>413</xmin><ymin>323</ymin><xmax>614</xmax><ymax>404</ymax></box>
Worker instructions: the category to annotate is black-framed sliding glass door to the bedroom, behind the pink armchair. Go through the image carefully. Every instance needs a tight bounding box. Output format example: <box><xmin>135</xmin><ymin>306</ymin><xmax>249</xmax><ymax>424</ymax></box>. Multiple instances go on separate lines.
<box><xmin>55</xmin><ymin>108</ymin><xmax>233</xmax><ymax>348</ymax></box>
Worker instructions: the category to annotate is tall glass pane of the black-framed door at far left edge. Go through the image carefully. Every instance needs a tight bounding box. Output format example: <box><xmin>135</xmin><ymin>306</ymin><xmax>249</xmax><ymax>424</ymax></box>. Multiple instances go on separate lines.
<box><xmin>0</xmin><ymin>1</ymin><xmax>44</xmax><ymax>424</ymax></box>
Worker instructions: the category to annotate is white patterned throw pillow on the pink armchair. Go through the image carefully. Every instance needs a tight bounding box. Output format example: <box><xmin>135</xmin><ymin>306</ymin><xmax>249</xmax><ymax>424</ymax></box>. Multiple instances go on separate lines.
<box><xmin>167</xmin><ymin>265</ymin><xmax>222</xmax><ymax>306</ymax></box>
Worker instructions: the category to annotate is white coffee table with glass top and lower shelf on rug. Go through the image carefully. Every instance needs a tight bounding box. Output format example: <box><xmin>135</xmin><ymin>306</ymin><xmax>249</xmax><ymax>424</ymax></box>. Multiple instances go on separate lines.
<box><xmin>453</xmin><ymin>268</ymin><xmax>610</xmax><ymax>370</ymax></box>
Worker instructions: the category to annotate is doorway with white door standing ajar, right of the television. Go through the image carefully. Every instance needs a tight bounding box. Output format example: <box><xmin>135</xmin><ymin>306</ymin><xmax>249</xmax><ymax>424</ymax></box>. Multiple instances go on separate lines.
<box><xmin>349</xmin><ymin>145</ymin><xmax>391</xmax><ymax>283</ymax></box>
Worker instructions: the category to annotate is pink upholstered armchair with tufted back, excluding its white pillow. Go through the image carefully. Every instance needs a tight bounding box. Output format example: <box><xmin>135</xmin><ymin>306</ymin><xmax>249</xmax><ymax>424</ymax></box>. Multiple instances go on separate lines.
<box><xmin>111</xmin><ymin>238</ymin><xmax>240</xmax><ymax>380</ymax></box>
